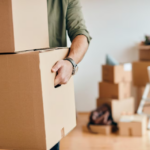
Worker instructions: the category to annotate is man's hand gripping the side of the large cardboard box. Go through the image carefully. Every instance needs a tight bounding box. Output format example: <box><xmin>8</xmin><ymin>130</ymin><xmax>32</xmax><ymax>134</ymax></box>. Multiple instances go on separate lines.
<box><xmin>52</xmin><ymin>60</ymin><xmax>73</xmax><ymax>86</ymax></box>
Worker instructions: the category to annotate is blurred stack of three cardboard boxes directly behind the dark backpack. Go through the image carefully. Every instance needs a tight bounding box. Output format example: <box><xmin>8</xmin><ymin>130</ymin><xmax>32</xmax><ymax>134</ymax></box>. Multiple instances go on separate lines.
<box><xmin>97</xmin><ymin>64</ymin><xmax>135</xmax><ymax>122</ymax></box>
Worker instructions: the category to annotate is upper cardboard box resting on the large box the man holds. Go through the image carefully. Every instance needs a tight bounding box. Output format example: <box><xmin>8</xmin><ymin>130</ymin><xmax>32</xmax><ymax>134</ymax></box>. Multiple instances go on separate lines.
<box><xmin>0</xmin><ymin>0</ymin><xmax>49</xmax><ymax>53</ymax></box>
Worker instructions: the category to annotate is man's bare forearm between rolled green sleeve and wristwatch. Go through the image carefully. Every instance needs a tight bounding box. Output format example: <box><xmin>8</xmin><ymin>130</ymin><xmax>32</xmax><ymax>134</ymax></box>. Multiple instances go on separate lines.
<box><xmin>68</xmin><ymin>35</ymin><xmax>89</xmax><ymax>64</ymax></box>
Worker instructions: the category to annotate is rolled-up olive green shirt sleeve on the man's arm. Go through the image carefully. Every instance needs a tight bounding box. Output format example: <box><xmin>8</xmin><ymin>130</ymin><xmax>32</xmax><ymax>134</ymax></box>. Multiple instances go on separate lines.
<box><xmin>66</xmin><ymin>0</ymin><xmax>92</xmax><ymax>43</ymax></box>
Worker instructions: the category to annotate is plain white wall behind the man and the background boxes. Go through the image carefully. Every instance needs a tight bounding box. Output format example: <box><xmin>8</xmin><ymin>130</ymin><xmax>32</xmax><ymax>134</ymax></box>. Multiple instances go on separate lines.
<box><xmin>68</xmin><ymin>0</ymin><xmax>150</xmax><ymax>112</ymax></box>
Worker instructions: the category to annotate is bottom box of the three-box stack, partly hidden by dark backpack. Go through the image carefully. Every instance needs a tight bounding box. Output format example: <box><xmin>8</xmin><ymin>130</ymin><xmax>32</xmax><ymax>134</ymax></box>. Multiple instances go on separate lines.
<box><xmin>97</xmin><ymin>97</ymin><xmax>135</xmax><ymax>122</ymax></box>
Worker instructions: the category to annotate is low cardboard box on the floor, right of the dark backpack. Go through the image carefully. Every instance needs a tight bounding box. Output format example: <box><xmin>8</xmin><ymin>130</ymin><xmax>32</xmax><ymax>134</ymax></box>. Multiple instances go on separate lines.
<box><xmin>119</xmin><ymin>115</ymin><xmax>147</xmax><ymax>136</ymax></box>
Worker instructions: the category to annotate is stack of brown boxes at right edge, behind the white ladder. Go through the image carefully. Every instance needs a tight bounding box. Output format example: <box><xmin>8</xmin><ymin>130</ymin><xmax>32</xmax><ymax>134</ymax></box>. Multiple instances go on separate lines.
<box><xmin>132</xmin><ymin>42</ymin><xmax>150</xmax><ymax>110</ymax></box>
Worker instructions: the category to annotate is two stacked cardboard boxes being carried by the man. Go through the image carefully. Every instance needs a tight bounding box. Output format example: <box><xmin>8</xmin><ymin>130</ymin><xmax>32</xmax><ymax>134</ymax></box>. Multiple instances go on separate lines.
<box><xmin>0</xmin><ymin>0</ymin><xmax>76</xmax><ymax>150</ymax></box>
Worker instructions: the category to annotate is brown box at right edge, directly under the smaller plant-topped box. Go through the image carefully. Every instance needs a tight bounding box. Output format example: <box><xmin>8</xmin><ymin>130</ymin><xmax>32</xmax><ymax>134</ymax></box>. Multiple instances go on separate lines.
<box><xmin>132</xmin><ymin>61</ymin><xmax>150</xmax><ymax>87</ymax></box>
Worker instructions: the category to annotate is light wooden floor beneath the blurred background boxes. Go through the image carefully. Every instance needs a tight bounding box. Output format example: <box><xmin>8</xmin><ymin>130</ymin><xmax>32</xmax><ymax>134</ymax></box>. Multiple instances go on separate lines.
<box><xmin>60</xmin><ymin>114</ymin><xmax>150</xmax><ymax>150</ymax></box>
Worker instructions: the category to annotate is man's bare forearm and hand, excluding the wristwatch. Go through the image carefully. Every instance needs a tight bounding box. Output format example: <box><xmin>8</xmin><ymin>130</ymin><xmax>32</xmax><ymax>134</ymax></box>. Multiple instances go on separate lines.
<box><xmin>52</xmin><ymin>35</ymin><xmax>89</xmax><ymax>86</ymax></box>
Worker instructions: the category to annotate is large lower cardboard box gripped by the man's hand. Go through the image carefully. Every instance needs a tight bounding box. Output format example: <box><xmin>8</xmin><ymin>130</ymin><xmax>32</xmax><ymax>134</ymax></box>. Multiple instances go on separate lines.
<box><xmin>0</xmin><ymin>48</ymin><xmax>76</xmax><ymax>150</ymax></box>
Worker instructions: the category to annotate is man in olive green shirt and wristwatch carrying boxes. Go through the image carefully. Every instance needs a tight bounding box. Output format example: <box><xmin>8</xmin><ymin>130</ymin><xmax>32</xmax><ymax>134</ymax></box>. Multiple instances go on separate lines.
<box><xmin>47</xmin><ymin>0</ymin><xmax>91</xmax><ymax>150</ymax></box>
